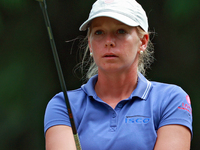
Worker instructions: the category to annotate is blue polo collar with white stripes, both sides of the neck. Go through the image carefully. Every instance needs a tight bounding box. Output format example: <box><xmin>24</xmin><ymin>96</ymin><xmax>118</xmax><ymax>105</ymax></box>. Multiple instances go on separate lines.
<box><xmin>81</xmin><ymin>73</ymin><xmax>152</xmax><ymax>100</ymax></box>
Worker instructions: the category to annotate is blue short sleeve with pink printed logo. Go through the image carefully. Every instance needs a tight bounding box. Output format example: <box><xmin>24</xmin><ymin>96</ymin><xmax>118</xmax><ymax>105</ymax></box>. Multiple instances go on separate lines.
<box><xmin>158</xmin><ymin>86</ymin><xmax>192</xmax><ymax>134</ymax></box>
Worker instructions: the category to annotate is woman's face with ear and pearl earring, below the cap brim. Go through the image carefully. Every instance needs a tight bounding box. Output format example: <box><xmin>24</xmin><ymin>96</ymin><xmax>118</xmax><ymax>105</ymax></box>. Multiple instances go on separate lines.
<box><xmin>88</xmin><ymin>17</ymin><xmax>148</xmax><ymax>73</ymax></box>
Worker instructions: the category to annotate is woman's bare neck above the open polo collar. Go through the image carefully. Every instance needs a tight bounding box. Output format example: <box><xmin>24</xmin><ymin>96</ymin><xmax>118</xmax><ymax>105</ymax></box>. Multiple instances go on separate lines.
<box><xmin>95</xmin><ymin>71</ymin><xmax>138</xmax><ymax>108</ymax></box>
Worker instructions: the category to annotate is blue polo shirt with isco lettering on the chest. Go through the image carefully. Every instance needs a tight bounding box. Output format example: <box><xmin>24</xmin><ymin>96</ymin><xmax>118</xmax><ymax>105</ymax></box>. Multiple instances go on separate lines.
<box><xmin>44</xmin><ymin>74</ymin><xmax>192</xmax><ymax>150</ymax></box>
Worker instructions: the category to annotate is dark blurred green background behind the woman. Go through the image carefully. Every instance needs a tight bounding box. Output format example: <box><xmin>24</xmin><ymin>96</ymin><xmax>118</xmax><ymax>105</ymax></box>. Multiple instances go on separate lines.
<box><xmin>0</xmin><ymin>0</ymin><xmax>200</xmax><ymax>150</ymax></box>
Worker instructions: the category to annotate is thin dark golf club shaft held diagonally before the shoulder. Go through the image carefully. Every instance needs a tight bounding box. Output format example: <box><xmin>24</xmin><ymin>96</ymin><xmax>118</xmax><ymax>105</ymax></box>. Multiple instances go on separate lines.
<box><xmin>37</xmin><ymin>0</ymin><xmax>81</xmax><ymax>150</ymax></box>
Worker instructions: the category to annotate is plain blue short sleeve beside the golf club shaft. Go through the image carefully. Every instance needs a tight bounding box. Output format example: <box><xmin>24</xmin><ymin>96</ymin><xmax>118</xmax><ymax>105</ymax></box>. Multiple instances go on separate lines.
<box><xmin>44</xmin><ymin>92</ymin><xmax>71</xmax><ymax>133</ymax></box>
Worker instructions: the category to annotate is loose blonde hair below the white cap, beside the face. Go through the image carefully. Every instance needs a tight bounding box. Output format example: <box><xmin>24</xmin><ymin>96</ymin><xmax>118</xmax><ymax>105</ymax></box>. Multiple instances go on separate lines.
<box><xmin>77</xmin><ymin>27</ymin><xmax>154</xmax><ymax>80</ymax></box>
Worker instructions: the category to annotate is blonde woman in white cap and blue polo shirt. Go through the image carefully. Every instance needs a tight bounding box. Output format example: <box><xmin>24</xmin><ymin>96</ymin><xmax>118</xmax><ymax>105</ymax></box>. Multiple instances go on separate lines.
<box><xmin>45</xmin><ymin>0</ymin><xmax>192</xmax><ymax>150</ymax></box>
